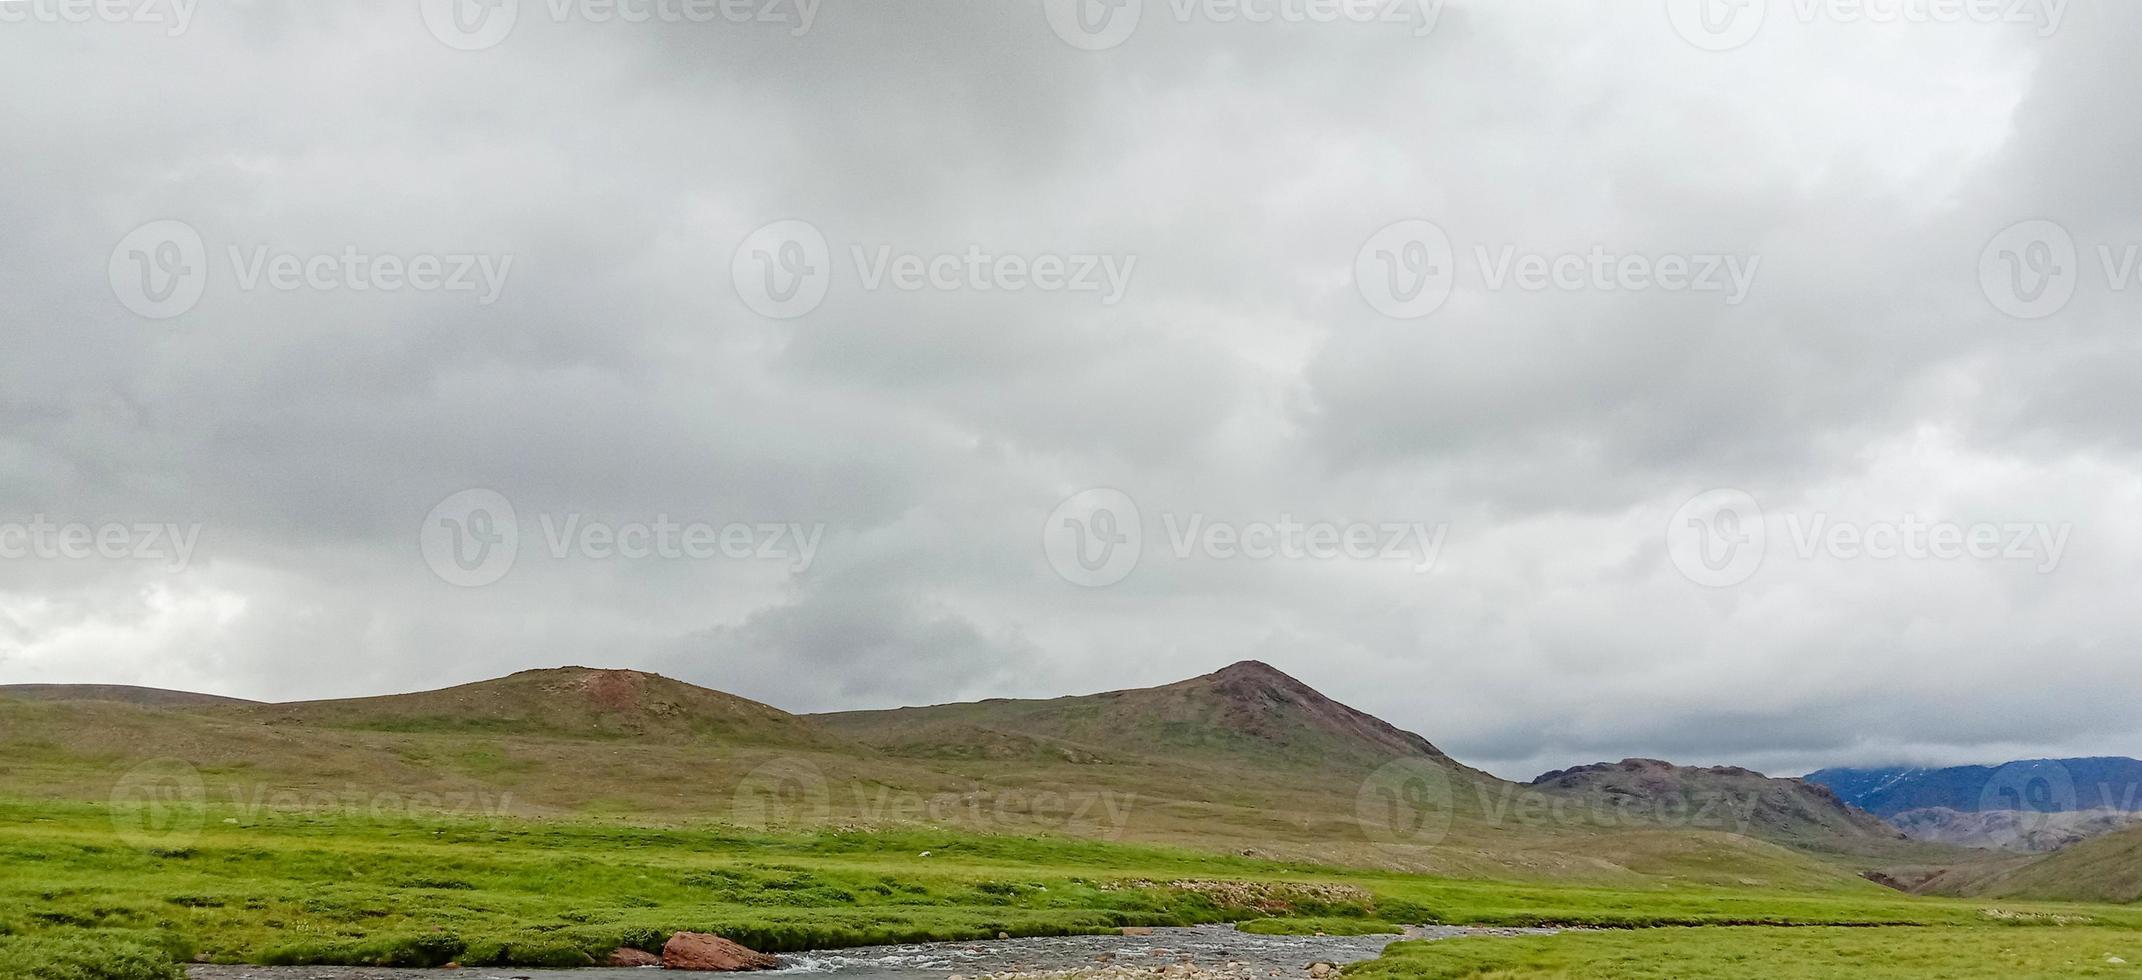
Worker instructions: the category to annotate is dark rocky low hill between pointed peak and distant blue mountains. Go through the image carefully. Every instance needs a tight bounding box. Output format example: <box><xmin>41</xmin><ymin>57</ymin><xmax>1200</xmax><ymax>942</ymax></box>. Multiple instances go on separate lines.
<box><xmin>1527</xmin><ymin>760</ymin><xmax>1904</xmax><ymax>849</ymax></box>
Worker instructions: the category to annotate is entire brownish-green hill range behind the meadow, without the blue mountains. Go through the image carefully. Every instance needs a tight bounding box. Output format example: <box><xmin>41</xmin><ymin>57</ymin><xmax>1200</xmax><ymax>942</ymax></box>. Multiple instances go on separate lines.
<box><xmin>0</xmin><ymin>661</ymin><xmax>1990</xmax><ymax>888</ymax></box>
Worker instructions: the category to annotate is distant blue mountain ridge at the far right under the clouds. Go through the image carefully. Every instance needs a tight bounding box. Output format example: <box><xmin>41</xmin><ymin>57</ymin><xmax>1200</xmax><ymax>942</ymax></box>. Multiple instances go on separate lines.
<box><xmin>1806</xmin><ymin>755</ymin><xmax>2142</xmax><ymax>817</ymax></box>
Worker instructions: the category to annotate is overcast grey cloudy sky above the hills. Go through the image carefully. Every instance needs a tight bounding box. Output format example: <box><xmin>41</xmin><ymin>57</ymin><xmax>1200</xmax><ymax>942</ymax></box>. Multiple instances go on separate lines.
<box><xmin>0</xmin><ymin>0</ymin><xmax>2142</xmax><ymax>779</ymax></box>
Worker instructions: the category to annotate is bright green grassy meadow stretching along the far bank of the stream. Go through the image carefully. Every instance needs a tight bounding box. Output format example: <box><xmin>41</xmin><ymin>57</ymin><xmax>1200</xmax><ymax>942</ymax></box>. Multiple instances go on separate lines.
<box><xmin>0</xmin><ymin>800</ymin><xmax>2142</xmax><ymax>978</ymax></box>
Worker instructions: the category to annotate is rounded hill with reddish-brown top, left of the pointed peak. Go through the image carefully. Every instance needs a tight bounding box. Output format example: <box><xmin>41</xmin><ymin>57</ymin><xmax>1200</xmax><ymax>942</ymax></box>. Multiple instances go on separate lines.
<box><xmin>246</xmin><ymin>668</ymin><xmax>833</xmax><ymax>747</ymax></box>
